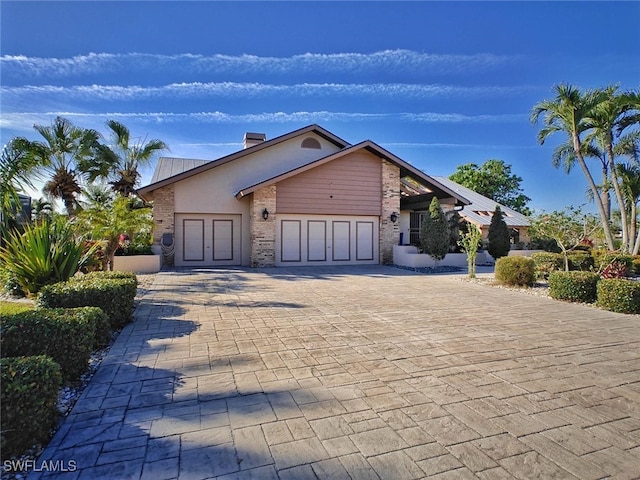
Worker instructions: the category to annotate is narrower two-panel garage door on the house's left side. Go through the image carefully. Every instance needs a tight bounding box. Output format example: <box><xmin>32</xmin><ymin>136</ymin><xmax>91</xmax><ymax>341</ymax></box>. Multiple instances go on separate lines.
<box><xmin>175</xmin><ymin>214</ymin><xmax>242</xmax><ymax>267</ymax></box>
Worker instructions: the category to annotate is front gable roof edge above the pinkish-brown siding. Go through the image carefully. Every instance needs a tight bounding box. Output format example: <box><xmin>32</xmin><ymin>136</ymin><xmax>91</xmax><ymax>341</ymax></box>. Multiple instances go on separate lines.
<box><xmin>236</xmin><ymin>140</ymin><xmax>470</xmax><ymax>205</ymax></box>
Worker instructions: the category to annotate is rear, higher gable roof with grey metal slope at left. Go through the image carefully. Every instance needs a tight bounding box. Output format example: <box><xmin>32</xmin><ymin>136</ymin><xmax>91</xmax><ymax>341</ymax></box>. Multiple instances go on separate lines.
<box><xmin>138</xmin><ymin>124</ymin><xmax>349</xmax><ymax>198</ymax></box>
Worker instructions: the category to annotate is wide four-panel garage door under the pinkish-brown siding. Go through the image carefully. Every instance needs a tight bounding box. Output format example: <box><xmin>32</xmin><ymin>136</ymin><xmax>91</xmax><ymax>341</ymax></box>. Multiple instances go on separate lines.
<box><xmin>276</xmin><ymin>215</ymin><xmax>379</xmax><ymax>266</ymax></box>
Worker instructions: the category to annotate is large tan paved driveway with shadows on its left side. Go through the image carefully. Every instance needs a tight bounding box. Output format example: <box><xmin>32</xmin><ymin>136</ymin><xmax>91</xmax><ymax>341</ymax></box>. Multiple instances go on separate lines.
<box><xmin>34</xmin><ymin>266</ymin><xmax>640</xmax><ymax>480</ymax></box>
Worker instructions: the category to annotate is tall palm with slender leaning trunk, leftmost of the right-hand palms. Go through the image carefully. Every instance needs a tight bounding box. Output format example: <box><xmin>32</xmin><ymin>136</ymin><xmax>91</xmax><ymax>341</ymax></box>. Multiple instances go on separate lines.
<box><xmin>531</xmin><ymin>84</ymin><xmax>615</xmax><ymax>250</ymax></box>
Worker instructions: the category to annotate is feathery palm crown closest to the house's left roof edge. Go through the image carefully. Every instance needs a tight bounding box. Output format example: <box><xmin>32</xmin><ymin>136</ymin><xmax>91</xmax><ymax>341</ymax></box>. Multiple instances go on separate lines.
<box><xmin>86</xmin><ymin>120</ymin><xmax>168</xmax><ymax>197</ymax></box>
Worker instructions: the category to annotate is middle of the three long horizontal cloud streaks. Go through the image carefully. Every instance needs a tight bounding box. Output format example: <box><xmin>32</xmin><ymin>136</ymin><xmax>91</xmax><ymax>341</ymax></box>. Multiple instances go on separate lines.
<box><xmin>0</xmin><ymin>82</ymin><xmax>537</xmax><ymax>101</ymax></box>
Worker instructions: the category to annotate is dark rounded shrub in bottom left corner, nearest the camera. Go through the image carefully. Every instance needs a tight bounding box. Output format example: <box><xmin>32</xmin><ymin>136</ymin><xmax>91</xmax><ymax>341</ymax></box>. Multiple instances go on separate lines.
<box><xmin>0</xmin><ymin>355</ymin><xmax>61</xmax><ymax>459</ymax></box>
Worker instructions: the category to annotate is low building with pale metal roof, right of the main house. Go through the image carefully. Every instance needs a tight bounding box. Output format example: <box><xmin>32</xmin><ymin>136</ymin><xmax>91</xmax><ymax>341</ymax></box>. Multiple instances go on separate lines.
<box><xmin>433</xmin><ymin>176</ymin><xmax>530</xmax><ymax>243</ymax></box>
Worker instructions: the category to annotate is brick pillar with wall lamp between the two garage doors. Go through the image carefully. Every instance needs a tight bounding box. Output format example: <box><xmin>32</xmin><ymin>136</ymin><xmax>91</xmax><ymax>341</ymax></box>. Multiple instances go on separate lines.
<box><xmin>250</xmin><ymin>185</ymin><xmax>276</xmax><ymax>267</ymax></box>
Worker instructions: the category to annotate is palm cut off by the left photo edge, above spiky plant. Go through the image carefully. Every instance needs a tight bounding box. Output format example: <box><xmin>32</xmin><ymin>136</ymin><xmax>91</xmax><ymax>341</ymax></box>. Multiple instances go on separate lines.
<box><xmin>0</xmin><ymin>137</ymin><xmax>43</xmax><ymax>233</ymax></box>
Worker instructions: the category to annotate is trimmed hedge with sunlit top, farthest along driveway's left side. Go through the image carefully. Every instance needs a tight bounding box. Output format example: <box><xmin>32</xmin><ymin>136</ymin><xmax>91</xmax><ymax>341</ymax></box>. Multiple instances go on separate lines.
<box><xmin>37</xmin><ymin>272</ymin><xmax>138</xmax><ymax>330</ymax></box>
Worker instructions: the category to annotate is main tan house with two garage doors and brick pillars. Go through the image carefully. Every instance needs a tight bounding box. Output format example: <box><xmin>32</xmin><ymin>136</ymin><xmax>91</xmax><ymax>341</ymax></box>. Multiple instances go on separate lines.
<box><xmin>138</xmin><ymin>125</ymin><xmax>470</xmax><ymax>266</ymax></box>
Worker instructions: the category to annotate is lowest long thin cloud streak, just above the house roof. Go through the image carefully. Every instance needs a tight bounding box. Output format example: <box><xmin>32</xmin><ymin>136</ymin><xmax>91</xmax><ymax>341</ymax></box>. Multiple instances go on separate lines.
<box><xmin>0</xmin><ymin>111</ymin><xmax>528</xmax><ymax>129</ymax></box>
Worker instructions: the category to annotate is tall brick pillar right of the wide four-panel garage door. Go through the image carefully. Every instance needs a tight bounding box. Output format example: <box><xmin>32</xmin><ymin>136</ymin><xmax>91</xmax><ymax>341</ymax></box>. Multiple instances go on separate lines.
<box><xmin>380</xmin><ymin>160</ymin><xmax>400</xmax><ymax>264</ymax></box>
